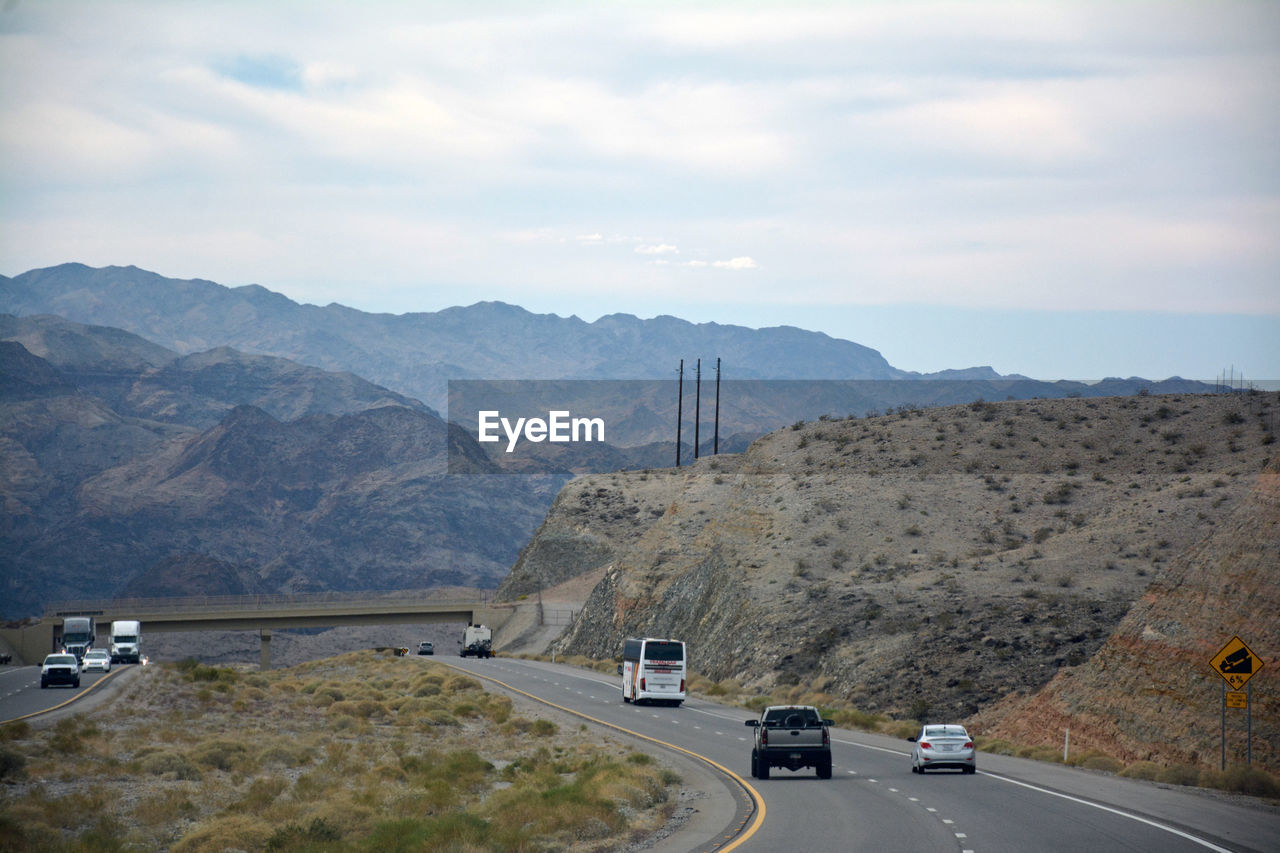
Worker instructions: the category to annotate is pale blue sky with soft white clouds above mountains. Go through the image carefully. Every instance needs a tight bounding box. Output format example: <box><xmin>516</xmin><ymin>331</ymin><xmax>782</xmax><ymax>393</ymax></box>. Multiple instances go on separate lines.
<box><xmin>0</xmin><ymin>0</ymin><xmax>1280</xmax><ymax>379</ymax></box>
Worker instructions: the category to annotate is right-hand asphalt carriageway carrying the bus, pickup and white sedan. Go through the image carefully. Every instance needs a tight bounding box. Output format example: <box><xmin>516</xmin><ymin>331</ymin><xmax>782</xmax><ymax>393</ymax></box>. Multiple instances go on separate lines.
<box><xmin>444</xmin><ymin>658</ymin><xmax>1280</xmax><ymax>853</ymax></box>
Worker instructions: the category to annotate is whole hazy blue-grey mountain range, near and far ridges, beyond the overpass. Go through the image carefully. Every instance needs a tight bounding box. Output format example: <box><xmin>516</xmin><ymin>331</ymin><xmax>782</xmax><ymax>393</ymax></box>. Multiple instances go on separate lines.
<box><xmin>0</xmin><ymin>264</ymin><xmax>1199</xmax><ymax>616</ymax></box>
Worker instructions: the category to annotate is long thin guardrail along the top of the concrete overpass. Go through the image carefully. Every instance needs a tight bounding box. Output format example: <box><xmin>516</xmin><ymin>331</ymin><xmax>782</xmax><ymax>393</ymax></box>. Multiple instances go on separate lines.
<box><xmin>45</xmin><ymin>588</ymin><xmax>493</xmax><ymax>619</ymax></box>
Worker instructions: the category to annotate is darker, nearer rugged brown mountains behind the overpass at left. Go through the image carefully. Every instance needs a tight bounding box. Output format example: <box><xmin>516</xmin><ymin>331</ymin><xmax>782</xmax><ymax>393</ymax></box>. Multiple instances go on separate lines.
<box><xmin>0</xmin><ymin>318</ymin><xmax>563</xmax><ymax>617</ymax></box>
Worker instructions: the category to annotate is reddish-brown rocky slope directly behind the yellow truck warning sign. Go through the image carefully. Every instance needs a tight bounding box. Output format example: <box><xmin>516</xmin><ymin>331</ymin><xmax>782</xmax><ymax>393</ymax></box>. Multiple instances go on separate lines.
<box><xmin>978</xmin><ymin>450</ymin><xmax>1280</xmax><ymax>772</ymax></box>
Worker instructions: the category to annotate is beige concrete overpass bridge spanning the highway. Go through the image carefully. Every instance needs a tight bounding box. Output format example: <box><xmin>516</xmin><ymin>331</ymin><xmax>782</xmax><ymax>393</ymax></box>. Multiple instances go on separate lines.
<box><xmin>0</xmin><ymin>589</ymin><xmax>516</xmax><ymax>670</ymax></box>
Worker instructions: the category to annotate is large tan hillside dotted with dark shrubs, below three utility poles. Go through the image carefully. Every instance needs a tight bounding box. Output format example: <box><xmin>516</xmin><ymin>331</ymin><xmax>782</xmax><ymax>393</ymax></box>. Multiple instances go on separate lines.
<box><xmin>502</xmin><ymin>394</ymin><xmax>1280</xmax><ymax>732</ymax></box>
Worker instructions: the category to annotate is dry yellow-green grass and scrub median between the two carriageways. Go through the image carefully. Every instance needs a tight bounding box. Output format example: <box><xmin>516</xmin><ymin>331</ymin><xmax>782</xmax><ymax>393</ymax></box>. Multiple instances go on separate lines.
<box><xmin>0</xmin><ymin>652</ymin><xmax>678</xmax><ymax>853</ymax></box>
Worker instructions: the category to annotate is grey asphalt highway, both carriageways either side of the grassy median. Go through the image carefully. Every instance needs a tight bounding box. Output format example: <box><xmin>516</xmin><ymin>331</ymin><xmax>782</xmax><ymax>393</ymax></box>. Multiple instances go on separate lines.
<box><xmin>0</xmin><ymin>657</ymin><xmax>1280</xmax><ymax>853</ymax></box>
